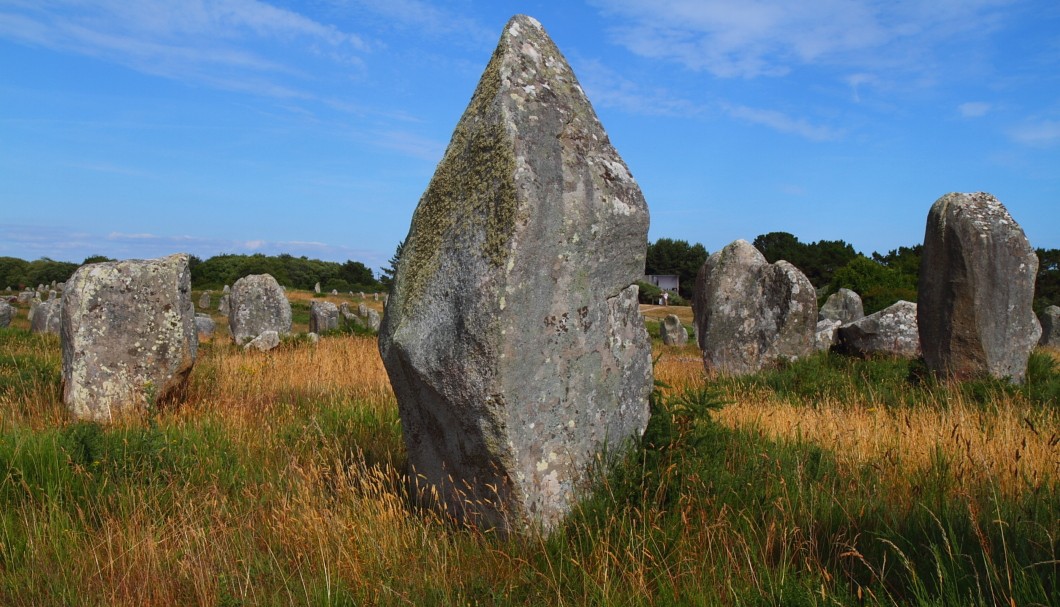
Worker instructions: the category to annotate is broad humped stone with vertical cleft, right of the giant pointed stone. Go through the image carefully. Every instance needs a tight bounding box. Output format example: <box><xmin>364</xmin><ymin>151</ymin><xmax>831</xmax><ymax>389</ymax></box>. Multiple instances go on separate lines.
<box><xmin>692</xmin><ymin>240</ymin><xmax>817</xmax><ymax>375</ymax></box>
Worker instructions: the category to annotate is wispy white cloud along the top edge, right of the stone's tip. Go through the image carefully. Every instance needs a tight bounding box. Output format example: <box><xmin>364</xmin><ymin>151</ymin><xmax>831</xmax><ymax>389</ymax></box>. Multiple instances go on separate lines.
<box><xmin>590</xmin><ymin>0</ymin><xmax>1012</xmax><ymax>77</ymax></box>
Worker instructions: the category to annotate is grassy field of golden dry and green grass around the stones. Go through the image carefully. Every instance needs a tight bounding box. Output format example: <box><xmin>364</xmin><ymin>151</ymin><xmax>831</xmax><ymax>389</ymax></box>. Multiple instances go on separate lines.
<box><xmin>0</xmin><ymin>293</ymin><xmax>1060</xmax><ymax>606</ymax></box>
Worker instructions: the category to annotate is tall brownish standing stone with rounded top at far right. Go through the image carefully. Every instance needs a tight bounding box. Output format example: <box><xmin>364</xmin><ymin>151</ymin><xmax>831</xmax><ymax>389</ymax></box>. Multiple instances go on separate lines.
<box><xmin>917</xmin><ymin>192</ymin><xmax>1041</xmax><ymax>382</ymax></box>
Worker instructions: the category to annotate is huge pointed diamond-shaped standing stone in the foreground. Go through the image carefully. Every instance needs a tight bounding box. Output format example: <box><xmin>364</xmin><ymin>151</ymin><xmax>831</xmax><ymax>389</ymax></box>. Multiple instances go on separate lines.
<box><xmin>379</xmin><ymin>16</ymin><xmax>652</xmax><ymax>532</ymax></box>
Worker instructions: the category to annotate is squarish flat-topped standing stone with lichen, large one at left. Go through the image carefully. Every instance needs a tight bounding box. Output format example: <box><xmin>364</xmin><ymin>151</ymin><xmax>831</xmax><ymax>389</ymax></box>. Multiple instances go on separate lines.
<box><xmin>60</xmin><ymin>254</ymin><xmax>198</xmax><ymax>422</ymax></box>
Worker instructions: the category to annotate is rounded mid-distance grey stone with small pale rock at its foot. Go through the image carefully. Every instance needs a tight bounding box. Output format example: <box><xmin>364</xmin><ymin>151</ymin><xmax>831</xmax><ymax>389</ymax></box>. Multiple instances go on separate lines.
<box><xmin>228</xmin><ymin>274</ymin><xmax>290</xmax><ymax>345</ymax></box>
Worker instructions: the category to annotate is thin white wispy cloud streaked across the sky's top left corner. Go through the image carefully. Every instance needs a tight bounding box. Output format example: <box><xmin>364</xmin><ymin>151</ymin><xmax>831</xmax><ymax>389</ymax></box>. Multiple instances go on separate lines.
<box><xmin>0</xmin><ymin>0</ymin><xmax>369</xmax><ymax>96</ymax></box>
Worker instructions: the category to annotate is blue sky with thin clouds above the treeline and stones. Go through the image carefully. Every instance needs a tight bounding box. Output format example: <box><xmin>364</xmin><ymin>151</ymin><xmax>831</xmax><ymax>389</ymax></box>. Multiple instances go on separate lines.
<box><xmin>0</xmin><ymin>0</ymin><xmax>1060</xmax><ymax>268</ymax></box>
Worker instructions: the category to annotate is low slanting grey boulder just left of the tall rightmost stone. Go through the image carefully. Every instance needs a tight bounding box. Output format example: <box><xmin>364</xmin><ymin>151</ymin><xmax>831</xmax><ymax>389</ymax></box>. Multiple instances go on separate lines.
<box><xmin>838</xmin><ymin>301</ymin><xmax>920</xmax><ymax>358</ymax></box>
